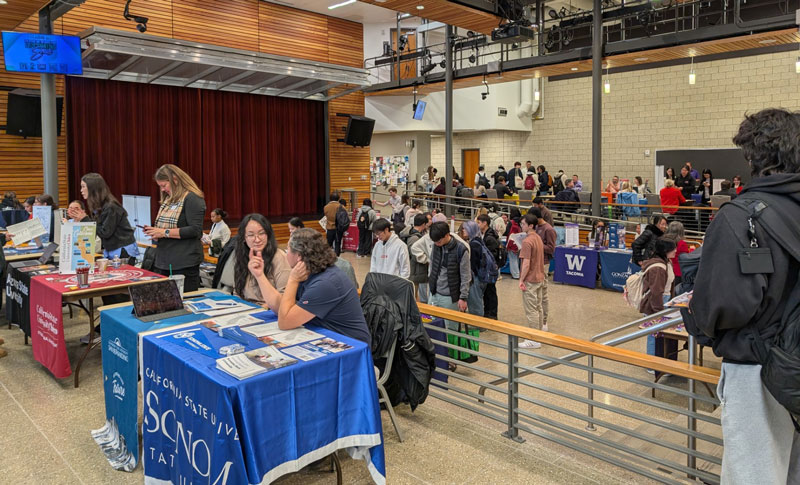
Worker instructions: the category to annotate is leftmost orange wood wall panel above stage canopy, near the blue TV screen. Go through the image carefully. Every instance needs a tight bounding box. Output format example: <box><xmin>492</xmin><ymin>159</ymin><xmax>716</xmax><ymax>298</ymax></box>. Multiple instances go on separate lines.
<box><xmin>61</xmin><ymin>0</ymin><xmax>172</xmax><ymax>37</ymax></box>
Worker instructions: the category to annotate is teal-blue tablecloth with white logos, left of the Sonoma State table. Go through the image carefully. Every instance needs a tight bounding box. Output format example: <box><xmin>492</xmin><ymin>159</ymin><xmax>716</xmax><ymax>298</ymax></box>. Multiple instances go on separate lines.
<box><xmin>100</xmin><ymin>292</ymin><xmax>257</xmax><ymax>471</ymax></box>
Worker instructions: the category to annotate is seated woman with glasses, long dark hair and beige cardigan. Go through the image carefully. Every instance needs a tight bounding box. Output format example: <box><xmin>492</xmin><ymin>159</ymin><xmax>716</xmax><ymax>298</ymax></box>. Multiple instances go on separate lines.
<box><xmin>233</xmin><ymin>214</ymin><xmax>291</xmax><ymax>311</ymax></box>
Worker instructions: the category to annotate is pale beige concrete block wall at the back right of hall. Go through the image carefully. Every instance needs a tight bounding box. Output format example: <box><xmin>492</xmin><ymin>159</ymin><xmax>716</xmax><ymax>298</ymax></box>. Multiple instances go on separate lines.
<box><xmin>431</xmin><ymin>51</ymin><xmax>800</xmax><ymax>187</ymax></box>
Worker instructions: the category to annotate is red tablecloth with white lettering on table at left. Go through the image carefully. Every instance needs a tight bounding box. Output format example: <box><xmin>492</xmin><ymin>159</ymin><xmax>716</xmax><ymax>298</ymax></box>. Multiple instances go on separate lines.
<box><xmin>30</xmin><ymin>265</ymin><xmax>164</xmax><ymax>378</ymax></box>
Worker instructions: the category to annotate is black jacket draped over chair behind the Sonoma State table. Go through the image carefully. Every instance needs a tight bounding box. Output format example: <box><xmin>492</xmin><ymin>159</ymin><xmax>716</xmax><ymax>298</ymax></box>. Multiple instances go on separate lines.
<box><xmin>361</xmin><ymin>273</ymin><xmax>435</xmax><ymax>411</ymax></box>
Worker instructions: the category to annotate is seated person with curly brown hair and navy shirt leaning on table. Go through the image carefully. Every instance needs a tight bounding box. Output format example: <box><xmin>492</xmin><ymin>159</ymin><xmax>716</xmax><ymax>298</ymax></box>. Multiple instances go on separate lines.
<box><xmin>248</xmin><ymin>228</ymin><xmax>371</xmax><ymax>344</ymax></box>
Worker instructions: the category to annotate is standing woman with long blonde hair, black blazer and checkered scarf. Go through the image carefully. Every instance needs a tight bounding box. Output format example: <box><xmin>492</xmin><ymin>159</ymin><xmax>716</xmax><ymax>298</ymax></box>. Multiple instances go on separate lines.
<box><xmin>144</xmin><ymin>163</ymin><xmax>206</xmax><ymax>291</ymax></box>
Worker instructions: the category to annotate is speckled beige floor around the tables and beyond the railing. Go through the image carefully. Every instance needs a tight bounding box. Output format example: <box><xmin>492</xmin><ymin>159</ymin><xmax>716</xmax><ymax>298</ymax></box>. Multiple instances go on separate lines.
<box><xmin>0</xmin><ymin>253</ymin><xmax>718</xmax><ymax>484</ymax></box>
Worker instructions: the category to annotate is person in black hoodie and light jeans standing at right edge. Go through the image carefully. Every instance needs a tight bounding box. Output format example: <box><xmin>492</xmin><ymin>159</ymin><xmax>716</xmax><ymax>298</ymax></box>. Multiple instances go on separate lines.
<box><xmin>683</xmin><ymin>109</ymin><xmax>800</xmax><ymax>484</ymax></box>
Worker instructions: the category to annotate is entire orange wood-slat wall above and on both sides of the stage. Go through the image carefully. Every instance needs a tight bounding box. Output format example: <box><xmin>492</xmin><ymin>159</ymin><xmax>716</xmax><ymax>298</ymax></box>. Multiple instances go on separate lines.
<box><xmin>0</xmin><ymin>0</ymin><xmax>369</xmax><ymax>210</ymax></box>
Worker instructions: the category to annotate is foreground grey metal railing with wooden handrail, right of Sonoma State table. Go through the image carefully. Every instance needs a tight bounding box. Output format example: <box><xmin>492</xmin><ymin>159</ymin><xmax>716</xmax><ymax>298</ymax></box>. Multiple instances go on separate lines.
<box><xmin>420</xmin><ymin>304</ymin><xmax>723</xmax><ymax>483</ymax></box>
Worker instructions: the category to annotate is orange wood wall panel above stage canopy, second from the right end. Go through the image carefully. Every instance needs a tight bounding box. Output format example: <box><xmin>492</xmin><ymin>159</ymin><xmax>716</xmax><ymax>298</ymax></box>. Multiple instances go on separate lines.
<box><xmin>259</xmin><ymin>2</ymin><xmax>330</xmax><ymax>62</ymax></box>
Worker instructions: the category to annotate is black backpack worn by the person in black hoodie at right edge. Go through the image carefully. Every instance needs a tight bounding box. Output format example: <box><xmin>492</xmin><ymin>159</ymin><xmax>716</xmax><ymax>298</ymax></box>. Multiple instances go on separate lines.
<box><xmin>726</xmin><ymin>192</ymin><xmax>800</xmax><ymax>432</ymax></box>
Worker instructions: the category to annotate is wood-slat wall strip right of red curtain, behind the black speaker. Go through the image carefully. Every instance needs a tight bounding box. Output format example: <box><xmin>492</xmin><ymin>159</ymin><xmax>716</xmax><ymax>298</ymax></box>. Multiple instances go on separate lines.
<box><xmin>328</xmin><ymin>88</ymin><xmax>369</xmax><ymax>191</ymax></box>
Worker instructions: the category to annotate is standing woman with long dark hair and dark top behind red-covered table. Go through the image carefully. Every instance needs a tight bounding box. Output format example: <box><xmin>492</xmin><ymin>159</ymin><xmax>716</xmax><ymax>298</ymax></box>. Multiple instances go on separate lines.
<box><xmin>67</xmin><ymin>173</ymin><xmax>139</xmax><ymax>259</ymax></box>
